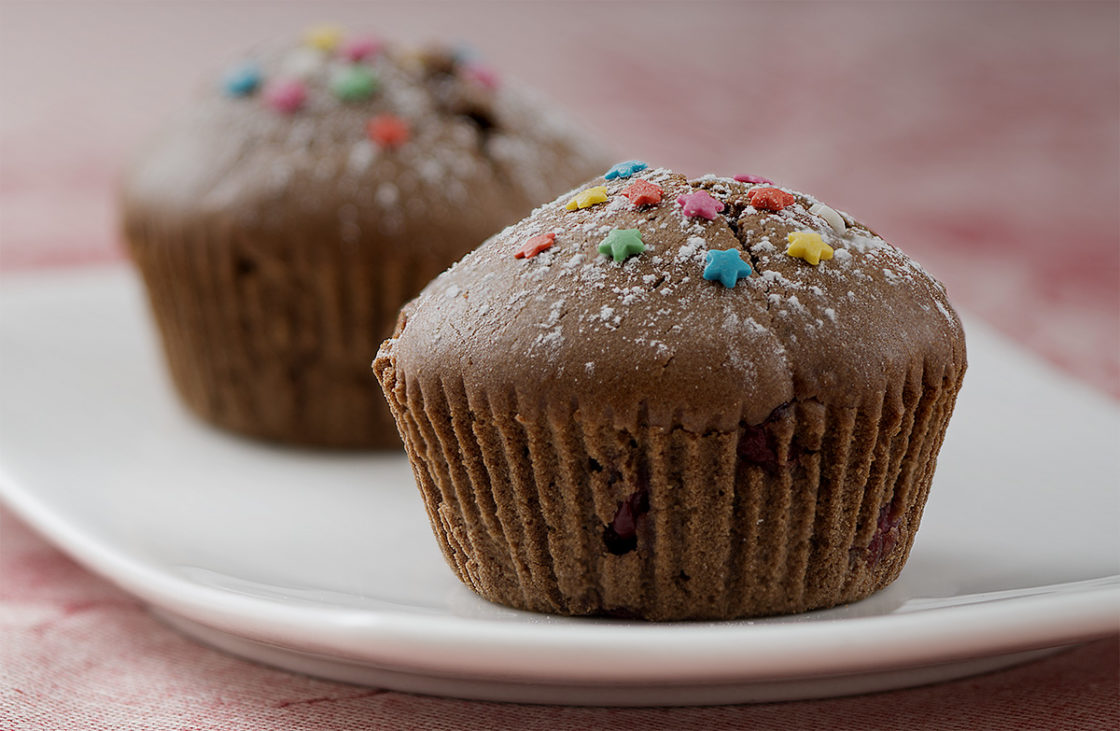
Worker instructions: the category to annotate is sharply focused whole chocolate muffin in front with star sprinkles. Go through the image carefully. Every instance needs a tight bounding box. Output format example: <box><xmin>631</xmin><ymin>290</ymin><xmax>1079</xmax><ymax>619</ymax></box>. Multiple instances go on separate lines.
<box><xmin>374</xmin><ymin>161</ymin><xmax>965</xmax><ymax>620</ymax></box>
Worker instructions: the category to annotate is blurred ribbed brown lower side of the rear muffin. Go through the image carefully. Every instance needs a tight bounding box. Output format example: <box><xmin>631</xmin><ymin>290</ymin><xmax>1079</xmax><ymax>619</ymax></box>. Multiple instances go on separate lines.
<box><xmin>125</xmin><ymin>210</ymin><xmax>446</xmax><ymax>448</ymax></box>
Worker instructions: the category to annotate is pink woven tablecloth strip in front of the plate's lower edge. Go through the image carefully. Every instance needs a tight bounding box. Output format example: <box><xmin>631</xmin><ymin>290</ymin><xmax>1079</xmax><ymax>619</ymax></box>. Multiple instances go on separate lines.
<box><xmin>0</xmin><ymin>513</ymin><xmax>1120</xmax><ymax>731</ymax></box>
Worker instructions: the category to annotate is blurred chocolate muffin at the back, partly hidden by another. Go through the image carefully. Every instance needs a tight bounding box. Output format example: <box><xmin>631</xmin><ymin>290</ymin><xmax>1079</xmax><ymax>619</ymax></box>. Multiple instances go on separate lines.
<box><xmin>122</xmin><ymin>28</ymin><xmax>603</xmax><ymax>448</ymax></box>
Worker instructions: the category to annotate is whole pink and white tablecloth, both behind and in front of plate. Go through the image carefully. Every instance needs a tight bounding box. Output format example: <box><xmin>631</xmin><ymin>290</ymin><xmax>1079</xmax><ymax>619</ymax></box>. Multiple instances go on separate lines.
<box><xmin>0</xmin><ymin>2</ymin><xmax>1120</xmax><ymax>730</ymax></box>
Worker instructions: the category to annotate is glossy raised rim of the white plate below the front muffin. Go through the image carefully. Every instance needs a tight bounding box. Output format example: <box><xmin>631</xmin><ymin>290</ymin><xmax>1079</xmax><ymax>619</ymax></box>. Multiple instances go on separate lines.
<box><xmin>0</xmin><ymin>265</ymin><xmax>1120</xmax><ymax>684</ymax></box>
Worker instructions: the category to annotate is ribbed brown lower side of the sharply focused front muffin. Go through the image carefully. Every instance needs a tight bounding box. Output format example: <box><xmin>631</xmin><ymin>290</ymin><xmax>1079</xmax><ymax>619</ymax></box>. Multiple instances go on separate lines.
<box><xmin>374</xmin><ymin>350</ymin><xmax>962</xmax><ymax>620</ymax></box>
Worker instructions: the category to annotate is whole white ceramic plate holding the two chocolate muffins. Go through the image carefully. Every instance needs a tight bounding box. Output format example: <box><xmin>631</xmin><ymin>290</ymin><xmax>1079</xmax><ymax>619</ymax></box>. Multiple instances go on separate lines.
<box><xmin>0</xmin><ymin>265</ymin><xmax>1120</xmax><ymax>705</ymax></box>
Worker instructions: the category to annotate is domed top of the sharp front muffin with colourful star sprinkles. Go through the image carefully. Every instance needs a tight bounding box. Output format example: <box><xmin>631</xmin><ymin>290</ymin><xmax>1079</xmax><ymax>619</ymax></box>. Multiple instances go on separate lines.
<box><xmin>379</xmin><ymin>161</ymin><xmax>964</xmax><ymax>431</ymax></box>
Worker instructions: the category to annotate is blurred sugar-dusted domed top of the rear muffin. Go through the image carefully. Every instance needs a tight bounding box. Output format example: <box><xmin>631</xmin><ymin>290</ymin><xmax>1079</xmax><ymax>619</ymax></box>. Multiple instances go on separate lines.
<box><xmin>123</xmin><ymin>27</ymin><xmax>601</xmax><ymax>255</ymax></box>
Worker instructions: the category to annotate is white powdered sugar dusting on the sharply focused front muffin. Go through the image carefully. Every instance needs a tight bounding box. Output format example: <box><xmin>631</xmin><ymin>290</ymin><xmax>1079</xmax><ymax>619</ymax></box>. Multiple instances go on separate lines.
<box><xmin>398</xmin><ymin>168</ymin><xmax>951</xmax><ymax>407</ymax></box>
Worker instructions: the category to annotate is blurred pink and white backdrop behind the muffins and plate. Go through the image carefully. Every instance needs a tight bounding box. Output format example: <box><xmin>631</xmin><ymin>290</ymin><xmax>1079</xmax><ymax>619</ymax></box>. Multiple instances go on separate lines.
<box><xmin>0</xmin><ymin>1</ymin><xmax>1120</xmax><ymax>397</ymax></box>
